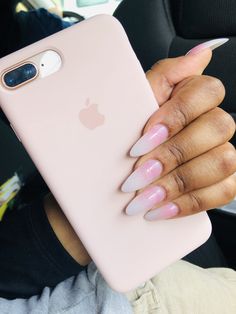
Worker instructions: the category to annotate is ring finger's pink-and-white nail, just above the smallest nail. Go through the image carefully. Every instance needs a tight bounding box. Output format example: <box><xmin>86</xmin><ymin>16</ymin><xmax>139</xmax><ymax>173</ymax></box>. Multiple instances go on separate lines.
<box><xmin>126</xmin><ymin>186</ymin><xmax>166</xmax><ymax>216</ymax></box>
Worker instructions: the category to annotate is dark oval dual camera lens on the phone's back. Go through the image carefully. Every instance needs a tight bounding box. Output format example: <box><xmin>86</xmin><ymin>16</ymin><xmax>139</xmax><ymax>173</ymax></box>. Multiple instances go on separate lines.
<box><xmin>3</xmin><ymin>63</ymin><xmax>37</xmax><ymax>88</ymax></box>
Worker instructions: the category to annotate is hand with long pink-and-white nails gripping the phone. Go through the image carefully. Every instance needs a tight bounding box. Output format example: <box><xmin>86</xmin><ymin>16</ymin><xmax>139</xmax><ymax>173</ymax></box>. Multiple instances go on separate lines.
<box><xmin>122</xmin><ymin>40</ymin><xmax>236</xmax><ymax>220</ymax></box>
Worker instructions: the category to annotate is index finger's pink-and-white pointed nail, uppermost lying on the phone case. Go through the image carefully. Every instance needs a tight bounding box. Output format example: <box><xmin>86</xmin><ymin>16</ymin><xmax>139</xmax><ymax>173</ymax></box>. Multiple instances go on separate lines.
<box><xmin>130</xmin><ymin>124</ymin><xmax>169</xmax><ymax>157</ymax></box>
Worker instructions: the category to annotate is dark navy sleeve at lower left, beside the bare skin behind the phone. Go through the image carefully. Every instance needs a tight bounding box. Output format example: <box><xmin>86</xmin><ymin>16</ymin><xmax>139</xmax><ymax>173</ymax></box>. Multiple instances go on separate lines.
<box><xmin>0</xmin><ymin>198</ymin><xmax>85</xmax><ymax>299</ymax></box>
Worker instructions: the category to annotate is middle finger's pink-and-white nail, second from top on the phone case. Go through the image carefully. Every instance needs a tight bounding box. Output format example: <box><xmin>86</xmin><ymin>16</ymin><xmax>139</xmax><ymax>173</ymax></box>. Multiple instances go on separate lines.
<box><xmin>121</xmin><ymin>159</ymin><xmax>163</xmax><ymax>192</ymax></box>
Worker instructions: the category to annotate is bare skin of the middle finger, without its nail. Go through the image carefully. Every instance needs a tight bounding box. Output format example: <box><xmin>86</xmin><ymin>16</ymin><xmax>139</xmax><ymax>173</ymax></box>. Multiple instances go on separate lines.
<box><xmin>138</xmin><ymin>108</ymin><xmax>235</xmax><ymax>176</ymax></box>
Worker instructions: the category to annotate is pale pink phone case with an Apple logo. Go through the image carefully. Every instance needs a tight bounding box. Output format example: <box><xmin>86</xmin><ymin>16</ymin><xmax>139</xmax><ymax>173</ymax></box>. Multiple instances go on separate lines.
<box><xmin>0</xmin><ymin>15</ymin><xmax>211</xmax><ymax>292</ymax></box>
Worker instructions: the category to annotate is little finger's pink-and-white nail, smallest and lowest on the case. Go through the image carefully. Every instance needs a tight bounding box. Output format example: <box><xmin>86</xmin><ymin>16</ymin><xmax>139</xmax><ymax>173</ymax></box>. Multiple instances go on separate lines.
<box><xmin>144</xmin><ymin>203</ymin><xmax>179</xmax><ymax>221</ymax></box>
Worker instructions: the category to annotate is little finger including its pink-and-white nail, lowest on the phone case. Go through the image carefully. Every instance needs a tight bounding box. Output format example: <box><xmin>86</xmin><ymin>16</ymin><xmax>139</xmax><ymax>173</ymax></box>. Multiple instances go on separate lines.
<box><xmin>145</xmin><ymin>175</ymin><xmax>236</xmax><ymax>221</ymax></box>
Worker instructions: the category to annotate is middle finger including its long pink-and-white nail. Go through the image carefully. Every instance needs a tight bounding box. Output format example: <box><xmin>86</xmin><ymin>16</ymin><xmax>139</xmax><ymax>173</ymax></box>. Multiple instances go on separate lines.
<box><xmin>122</xmin><ymin>108</ymin><xmax>235</xmax><ymax>192</ymax></box>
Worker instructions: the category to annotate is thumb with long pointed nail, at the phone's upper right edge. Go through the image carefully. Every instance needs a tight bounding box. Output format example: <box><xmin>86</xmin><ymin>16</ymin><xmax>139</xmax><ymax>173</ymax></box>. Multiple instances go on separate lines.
<box><xmin>146</xmin><ymin>38</ymin><xmax>228</xmax><ymax>106</ymax></box>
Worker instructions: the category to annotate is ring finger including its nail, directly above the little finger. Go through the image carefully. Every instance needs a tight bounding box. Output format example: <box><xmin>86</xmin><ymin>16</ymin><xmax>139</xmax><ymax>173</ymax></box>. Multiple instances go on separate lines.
<box><xmin>123</xmin><ymin>143</ymin><xmax>236</xmax><ymax>215</ymax></box>
